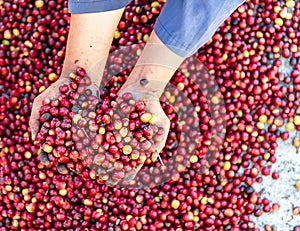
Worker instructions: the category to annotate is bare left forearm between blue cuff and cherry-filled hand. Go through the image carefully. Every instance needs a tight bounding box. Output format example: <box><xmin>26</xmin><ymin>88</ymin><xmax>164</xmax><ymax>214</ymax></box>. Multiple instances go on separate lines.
<box><xmin>62</xmin><ymin>8</ymin><xmax>124</xmax><ymax>85</ymax></box>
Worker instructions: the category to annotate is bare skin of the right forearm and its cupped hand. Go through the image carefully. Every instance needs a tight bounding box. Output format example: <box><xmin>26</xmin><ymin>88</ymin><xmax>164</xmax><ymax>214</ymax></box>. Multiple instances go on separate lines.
<box><xmin>115</xmin><ymin>31</ymin><xmax>185</xmax><ymax>186</ymax></box>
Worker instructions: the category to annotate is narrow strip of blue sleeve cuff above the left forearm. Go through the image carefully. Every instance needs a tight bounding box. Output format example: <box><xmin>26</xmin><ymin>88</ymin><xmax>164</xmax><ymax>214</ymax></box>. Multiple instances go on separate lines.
<box><xmin>68</xmin><ymin>0</ymin><xmax>130</xmax><ymax>14</ymax></box>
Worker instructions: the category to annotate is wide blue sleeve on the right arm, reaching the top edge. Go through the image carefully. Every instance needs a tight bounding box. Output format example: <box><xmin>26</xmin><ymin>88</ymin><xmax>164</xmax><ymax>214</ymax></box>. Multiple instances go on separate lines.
<box><xmin>154</xmin><ymin>0</ymin><xmax>244</xmax><ymax>57</ymax></box>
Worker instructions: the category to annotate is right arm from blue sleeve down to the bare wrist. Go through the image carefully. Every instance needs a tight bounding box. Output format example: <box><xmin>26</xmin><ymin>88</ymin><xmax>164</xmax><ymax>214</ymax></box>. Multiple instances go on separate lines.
<box><xmin>123</xmin><ymin>0</ymin><xmax>245</xmax><ymax>97</ymax></box>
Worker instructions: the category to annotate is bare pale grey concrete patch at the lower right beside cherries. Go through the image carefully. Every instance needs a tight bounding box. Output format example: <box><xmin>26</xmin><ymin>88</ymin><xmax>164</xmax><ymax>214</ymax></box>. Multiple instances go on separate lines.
<box><xmin>252</xmin><ymin>132</ymin><xmax>300</xmax><ymax>231</ymax></box>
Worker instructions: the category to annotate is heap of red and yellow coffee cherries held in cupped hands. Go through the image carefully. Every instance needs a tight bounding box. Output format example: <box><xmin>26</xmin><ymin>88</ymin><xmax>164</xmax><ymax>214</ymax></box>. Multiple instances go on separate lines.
<box><xmin>36</xmin><ymin>69</ymin><xmax>164</xmax><ymax>186</ymax></box>
